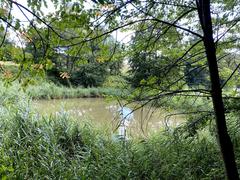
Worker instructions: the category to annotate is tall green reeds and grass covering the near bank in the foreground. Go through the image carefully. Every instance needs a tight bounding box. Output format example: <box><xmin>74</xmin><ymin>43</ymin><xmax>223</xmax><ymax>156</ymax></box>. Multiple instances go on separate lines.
<box><xmin>0</xmin><ymin>80</ymin><xmax>240</xmax><ymax>179</ymax></box>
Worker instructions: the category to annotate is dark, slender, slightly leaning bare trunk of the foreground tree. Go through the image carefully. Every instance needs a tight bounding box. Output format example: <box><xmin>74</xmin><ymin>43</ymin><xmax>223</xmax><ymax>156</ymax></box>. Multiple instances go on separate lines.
<box><xmin>196</xmin><ymin>0</ymin><xmax>239</xmax><ymax>180</ymax></box>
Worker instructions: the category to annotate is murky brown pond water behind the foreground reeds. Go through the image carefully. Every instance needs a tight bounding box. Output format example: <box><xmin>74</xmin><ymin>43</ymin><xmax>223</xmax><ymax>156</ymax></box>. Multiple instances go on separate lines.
<box><xmin>33</xmin><ymin>98</ymin><xmax>183</xmax><ymax>135</ymax></box>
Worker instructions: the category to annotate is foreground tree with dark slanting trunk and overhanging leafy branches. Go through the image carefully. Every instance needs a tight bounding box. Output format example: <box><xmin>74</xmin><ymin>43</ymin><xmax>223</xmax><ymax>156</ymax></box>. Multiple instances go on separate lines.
<box><xmin>2</xmin><ymin>0</ymin><xmax>240</xmax><ymax>179</ymax></box>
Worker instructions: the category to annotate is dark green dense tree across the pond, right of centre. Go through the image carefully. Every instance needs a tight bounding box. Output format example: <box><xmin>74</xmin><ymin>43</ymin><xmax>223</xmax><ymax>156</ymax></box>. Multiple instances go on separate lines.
<box><xmin>128</xmin><ymin>24</ymin><xmax>181</xmax><ymax>89</ymax></box>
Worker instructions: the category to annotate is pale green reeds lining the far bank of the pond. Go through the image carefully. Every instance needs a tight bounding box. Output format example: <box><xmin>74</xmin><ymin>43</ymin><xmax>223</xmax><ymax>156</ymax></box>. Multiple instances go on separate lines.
<box><xmin>0</xmin><ymin>61</ymin><xmax>128</xmax><ymax>99</ymax></box>
